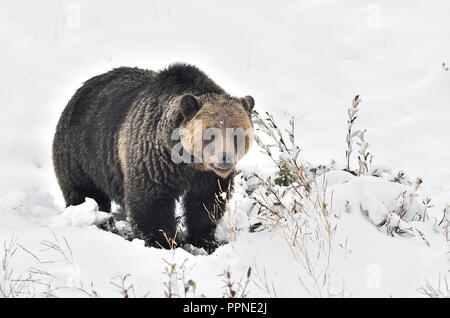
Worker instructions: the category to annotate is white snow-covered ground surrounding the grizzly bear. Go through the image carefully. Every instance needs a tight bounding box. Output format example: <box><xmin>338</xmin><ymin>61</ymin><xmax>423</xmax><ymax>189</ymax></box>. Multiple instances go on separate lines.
<box><xmin>0</xmin><ymin>0</ymin><xmax>450</xmax><ymax>297</ymax></box>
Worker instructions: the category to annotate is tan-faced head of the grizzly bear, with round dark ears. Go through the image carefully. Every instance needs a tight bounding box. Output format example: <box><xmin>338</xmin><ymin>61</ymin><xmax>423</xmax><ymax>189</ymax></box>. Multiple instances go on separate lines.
<box><xmin>172</xmin><ymin>94</ymin><xmax>255</xmax><ymax>178</ymax></box>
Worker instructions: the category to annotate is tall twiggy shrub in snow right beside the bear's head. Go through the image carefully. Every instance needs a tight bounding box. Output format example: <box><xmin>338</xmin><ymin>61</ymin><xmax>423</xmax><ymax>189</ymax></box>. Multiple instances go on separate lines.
<box><xmin>251</xmin><ymin>114</ymin><xmax>340</xmax><ymax>297</ymax></box>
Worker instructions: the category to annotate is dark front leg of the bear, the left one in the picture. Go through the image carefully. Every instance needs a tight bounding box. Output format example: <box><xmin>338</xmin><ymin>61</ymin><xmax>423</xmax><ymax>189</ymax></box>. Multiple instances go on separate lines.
<box><xmin>126</xmin><ymin>190</ymin><xmax>176</xmax><ymax>249</ymax></box>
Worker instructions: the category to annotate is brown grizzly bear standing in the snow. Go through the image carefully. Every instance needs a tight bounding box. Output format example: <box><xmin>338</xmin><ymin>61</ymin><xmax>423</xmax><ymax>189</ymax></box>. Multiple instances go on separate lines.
<box><xmin>53</xmin><ymin>63</ymin><xmax>254</xmax><ymax>248</ymax></box>
